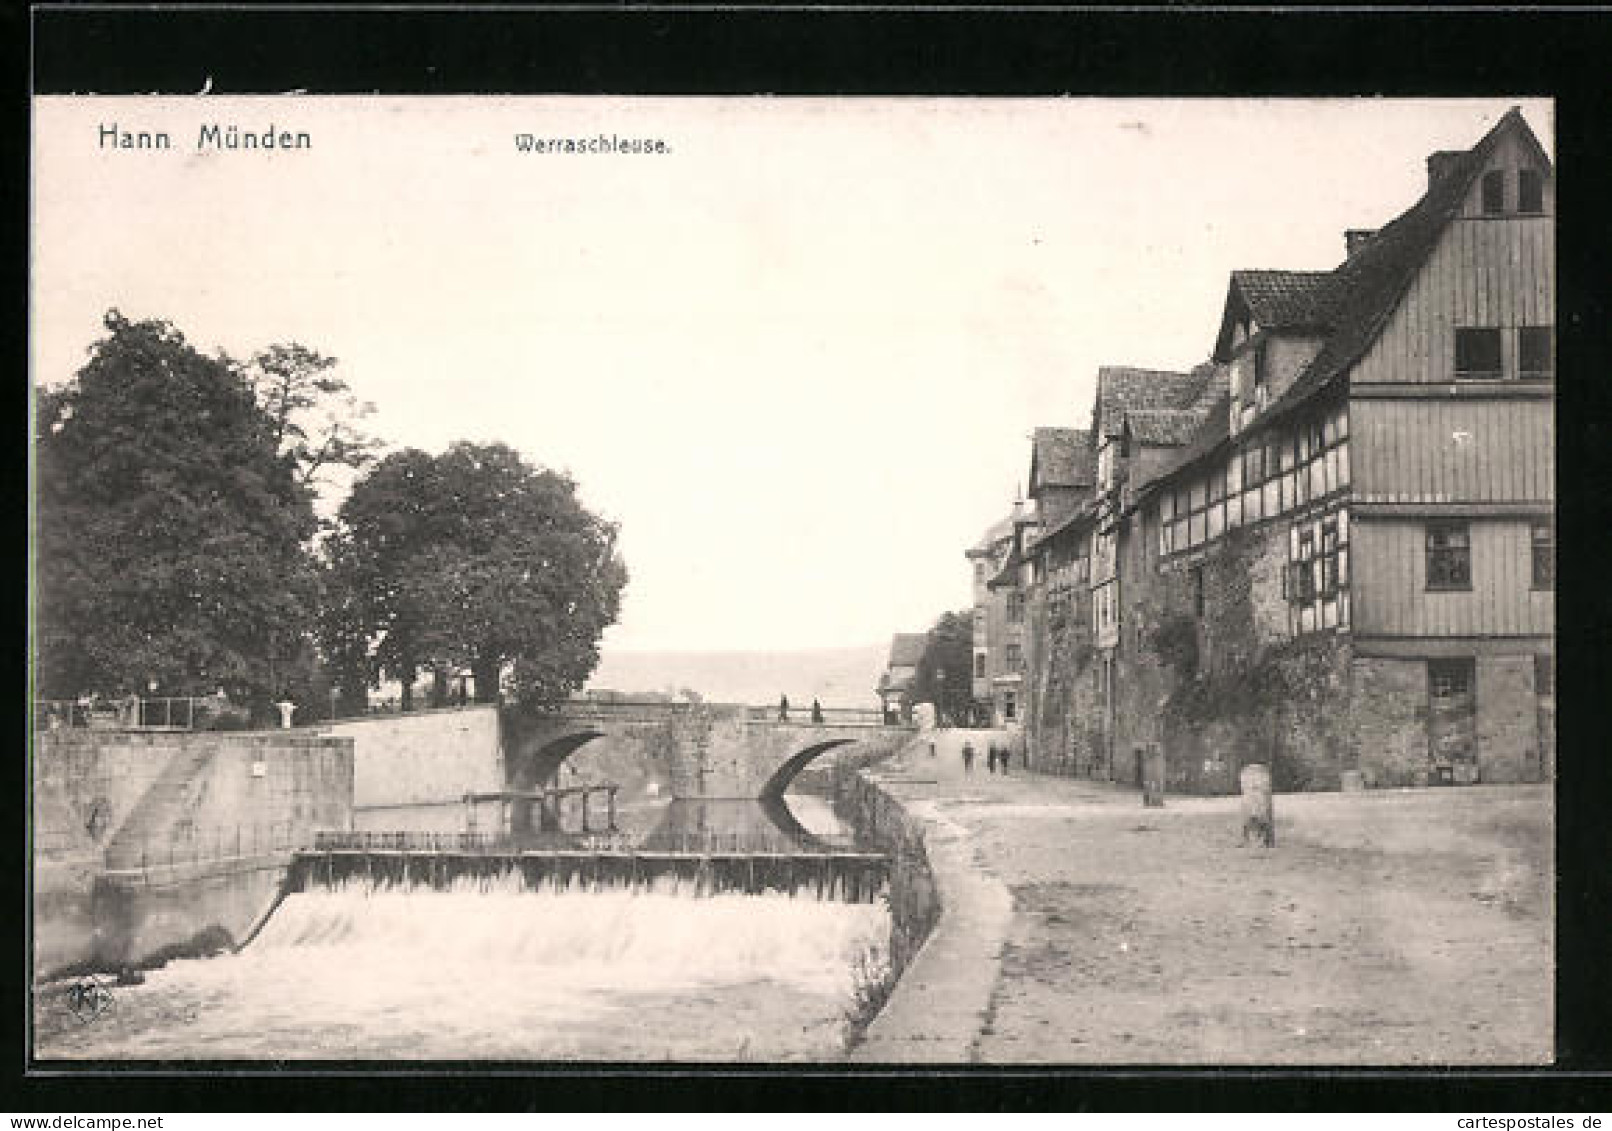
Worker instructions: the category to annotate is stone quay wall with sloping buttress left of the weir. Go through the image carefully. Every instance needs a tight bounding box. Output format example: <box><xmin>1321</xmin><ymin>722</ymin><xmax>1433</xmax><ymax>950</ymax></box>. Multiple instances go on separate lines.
<box><xmin>31</xmin><ymin>730</ymin><xmax>353</xmax><ymax>978</ymax></box>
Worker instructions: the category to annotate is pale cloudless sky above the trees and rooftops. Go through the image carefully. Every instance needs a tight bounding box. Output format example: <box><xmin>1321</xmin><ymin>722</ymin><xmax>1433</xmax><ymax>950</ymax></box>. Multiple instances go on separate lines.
<box><xmin>32</xmin><ymin>97</ymin><xmax>1554</xmax><ymax>649</ymax></box>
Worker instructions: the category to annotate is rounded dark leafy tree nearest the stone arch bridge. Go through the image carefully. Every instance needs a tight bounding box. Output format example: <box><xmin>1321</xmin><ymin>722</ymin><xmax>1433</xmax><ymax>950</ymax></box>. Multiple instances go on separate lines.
<box><xmin>340</xmin><ymin>443</ymin><xmax>627</xmax><ymax>707</ymax></box>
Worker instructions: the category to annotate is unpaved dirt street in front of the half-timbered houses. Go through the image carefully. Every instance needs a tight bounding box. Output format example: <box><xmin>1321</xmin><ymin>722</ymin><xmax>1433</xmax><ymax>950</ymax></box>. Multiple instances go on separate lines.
<box><xmin>891</xmin><ymin>731</ymin><xmax>1554</xmax><ymax>1065</ymax></box>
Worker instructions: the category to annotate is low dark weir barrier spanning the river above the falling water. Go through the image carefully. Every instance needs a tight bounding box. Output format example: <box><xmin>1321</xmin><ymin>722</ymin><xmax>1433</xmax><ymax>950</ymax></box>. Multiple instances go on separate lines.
<box><xmin>285</xmin><ymin>838</ymin><xmax>890</xmax><ymax>904</ymax></box>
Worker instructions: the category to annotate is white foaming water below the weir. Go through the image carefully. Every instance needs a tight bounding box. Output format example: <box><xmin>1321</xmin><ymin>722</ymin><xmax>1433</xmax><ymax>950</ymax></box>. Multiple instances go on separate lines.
<box><xmin>37</xmin><ymin>876</ymin><xmax>890</xmax><ymax>1060</ymax></box>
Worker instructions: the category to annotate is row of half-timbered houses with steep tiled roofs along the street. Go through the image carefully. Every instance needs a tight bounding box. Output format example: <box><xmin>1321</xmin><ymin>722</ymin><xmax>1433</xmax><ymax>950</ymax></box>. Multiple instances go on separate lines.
<box><xmin>998</xmin><ymin>111</ymin><xmax>1556</xmax><ymax>791</ymax></box>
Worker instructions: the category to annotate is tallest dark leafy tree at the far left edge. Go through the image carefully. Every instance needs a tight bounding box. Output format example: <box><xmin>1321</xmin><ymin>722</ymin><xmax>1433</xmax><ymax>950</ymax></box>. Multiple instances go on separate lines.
<box><xmin>34</xmin><ymin>311</ymin><xmax>316</xmax><ymax>701</ymax></box>
